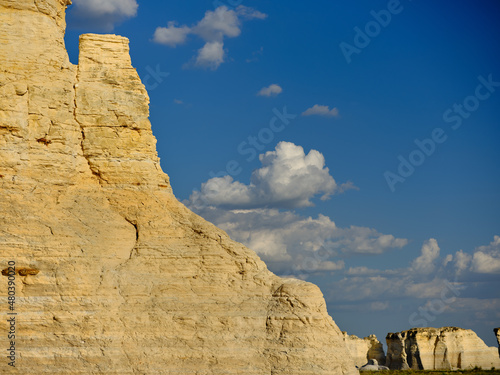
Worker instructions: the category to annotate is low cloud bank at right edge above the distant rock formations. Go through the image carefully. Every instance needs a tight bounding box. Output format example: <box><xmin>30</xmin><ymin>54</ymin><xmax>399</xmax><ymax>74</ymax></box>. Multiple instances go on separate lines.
<box><xmin>329</xmin><ymin>236</ymin><xmax>500</xmax><ymax>314</ymax></box>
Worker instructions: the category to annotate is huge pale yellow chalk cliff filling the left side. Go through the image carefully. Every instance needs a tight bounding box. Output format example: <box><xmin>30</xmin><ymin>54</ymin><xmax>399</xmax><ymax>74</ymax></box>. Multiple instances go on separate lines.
<box><xmin>0</xmin><ymin>0</ymin><xmax>357</xmax><ymax>375</ymax></box>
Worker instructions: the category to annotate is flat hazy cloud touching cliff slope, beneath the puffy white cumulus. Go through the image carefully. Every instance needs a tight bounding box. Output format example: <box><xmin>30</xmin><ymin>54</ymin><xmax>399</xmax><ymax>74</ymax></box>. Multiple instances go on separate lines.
<box><xmin>186</xmin><ymin>207</ymin><xmax>408</xmax><ymax>276</ymax></box>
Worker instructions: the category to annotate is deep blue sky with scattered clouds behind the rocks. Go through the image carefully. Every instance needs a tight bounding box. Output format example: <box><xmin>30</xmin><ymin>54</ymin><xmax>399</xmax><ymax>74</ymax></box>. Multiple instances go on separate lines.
<box><xmin>66</xmin><ymin>0</ymin><xmax>500</xmax><ymax>346</ymax></box>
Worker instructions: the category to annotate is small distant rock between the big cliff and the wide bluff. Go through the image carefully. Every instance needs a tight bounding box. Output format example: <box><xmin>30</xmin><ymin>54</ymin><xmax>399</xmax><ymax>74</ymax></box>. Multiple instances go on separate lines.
<box><xmin>342</xmin><ymin>332</ymin><xmax>385</xmax><ymax>367</ymax></box>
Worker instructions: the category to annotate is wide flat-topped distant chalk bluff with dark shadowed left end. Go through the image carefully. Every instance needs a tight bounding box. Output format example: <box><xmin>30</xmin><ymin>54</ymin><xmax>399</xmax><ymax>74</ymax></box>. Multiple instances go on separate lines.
<box><xmin>386</xmin><ymin>327</ymin><xmax>500</xmax><ymax>370</ymax></box>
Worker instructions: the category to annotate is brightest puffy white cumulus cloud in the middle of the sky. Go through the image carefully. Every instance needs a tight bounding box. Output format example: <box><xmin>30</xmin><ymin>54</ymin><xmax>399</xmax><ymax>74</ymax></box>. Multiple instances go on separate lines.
<box><xmin>190</xmin><ymin>142</ymin><xmax>361</xmax><ymax>210</ymax></box>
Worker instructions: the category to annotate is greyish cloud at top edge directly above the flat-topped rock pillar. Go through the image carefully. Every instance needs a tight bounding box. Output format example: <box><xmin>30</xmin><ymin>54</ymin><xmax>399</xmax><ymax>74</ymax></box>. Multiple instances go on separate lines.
<box><xmin>71</xmin><ymin>0</ymin><xmax>139</xmax><ymax>31</ymax></box>
